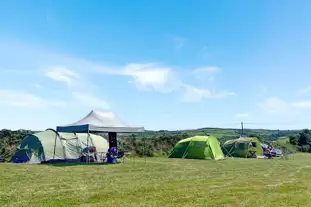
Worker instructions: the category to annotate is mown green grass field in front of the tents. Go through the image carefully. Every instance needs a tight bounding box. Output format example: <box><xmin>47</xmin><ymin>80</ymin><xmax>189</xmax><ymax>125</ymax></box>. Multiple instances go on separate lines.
<box><xmin>0</xmin><ymin>154</ymin><xmax>311</xmax><ymax>207</ymax></box>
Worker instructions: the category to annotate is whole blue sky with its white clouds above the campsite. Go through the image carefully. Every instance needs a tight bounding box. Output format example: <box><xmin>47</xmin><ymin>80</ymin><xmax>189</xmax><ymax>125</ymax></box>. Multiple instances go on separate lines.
<box><xmin>0</xmin><ymin>0</ymin><xmax>311</xmax><ymax>129</ymax></box>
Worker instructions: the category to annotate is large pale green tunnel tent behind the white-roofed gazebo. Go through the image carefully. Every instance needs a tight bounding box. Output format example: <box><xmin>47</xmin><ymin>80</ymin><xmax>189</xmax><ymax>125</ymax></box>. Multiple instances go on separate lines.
<box><xmin>11</xmin><ymin>129</ymin><xmax>109</xmax><ymax>163</ymax></box>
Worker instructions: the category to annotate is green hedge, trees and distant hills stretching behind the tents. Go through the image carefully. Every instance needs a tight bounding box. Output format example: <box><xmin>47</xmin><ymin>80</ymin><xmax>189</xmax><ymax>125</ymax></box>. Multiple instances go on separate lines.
<box><xmin>0</xmin><ymin>128</ymin><xmax>311</xmax><ymax>160</ymax></box>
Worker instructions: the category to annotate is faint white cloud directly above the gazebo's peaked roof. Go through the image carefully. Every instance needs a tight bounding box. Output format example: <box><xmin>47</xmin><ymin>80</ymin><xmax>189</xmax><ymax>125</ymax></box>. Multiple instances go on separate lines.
<box><xmin>72</xmin><ymin>92</ymin><xmax>109</xmax><ymax>110</ymax></box>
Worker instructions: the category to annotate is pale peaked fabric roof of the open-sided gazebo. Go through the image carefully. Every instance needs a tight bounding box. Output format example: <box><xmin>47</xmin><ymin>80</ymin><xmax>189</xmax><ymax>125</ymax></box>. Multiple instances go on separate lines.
<box><xmin>56</xmin><ymin>111</ymin><xmax>145</xmax><ymax>133</ymax></box>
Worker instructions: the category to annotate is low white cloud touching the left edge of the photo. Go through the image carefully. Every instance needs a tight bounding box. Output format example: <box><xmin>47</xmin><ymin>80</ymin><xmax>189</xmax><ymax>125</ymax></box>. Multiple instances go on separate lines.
<box><xmin>0</xmin><ymin>90</ymin><xmax>66</xmax><ymax>108</ymax></box>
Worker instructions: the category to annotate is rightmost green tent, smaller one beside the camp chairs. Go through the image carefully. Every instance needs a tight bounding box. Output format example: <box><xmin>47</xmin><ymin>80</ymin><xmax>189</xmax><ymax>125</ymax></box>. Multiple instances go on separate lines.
<box><xmin>223</xmin><ymin>137</ymin><xmax>263</xmax><ymax>158</ymax></box>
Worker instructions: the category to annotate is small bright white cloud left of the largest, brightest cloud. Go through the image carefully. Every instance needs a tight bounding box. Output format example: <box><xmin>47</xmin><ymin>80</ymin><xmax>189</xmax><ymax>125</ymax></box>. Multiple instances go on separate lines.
<box><xmin>45</xmin><ymin>67</ymin><xmax>80</xmax><ymax>86</ymax></box>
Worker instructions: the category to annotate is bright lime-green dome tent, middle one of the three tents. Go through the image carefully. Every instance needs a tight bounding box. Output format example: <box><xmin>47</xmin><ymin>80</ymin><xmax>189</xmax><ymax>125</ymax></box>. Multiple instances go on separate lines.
<box><xmin>168</xmin><ymin>136</ymin><xmax>224</xmax><ymax>160</ymax></box>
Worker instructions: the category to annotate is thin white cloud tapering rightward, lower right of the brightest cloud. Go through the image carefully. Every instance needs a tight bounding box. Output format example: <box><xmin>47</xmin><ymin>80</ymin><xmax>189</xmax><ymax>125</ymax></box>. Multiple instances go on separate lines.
<box><xmin>183</xmin><ymin>85</ymin><xmax>236</xmax><ymax>102</ymax></box>
